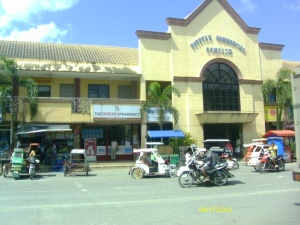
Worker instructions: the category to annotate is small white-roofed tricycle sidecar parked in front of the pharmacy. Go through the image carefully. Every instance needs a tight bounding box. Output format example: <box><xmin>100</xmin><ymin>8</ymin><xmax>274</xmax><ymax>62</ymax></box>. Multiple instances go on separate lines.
<box><xmin>64</xmin><ymin>149</ymin><xmax>90</xmax><ymax>176</ymax></box>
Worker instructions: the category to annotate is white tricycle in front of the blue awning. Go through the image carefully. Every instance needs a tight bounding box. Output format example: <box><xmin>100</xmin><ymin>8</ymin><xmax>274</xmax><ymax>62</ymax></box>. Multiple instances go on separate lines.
<box><xmin>128</xmin><ymin>148</ymin><xmax>176</xmax><ymax>179</ymax></box>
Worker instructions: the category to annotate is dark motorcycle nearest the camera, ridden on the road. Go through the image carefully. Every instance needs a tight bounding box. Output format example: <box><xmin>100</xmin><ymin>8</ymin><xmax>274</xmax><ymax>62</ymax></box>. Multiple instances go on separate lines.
<box><xmin>178</xmin><ymin>157</ymin><xmax>234</xmax><ymax>188</ymax></box>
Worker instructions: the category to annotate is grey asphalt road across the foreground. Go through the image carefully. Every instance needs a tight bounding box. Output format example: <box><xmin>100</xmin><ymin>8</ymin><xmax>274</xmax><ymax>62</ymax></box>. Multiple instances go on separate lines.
<box><xmin>0</xmin><ymin>163</ymin><xmax>300</xmax><ymax>225</ymax></box>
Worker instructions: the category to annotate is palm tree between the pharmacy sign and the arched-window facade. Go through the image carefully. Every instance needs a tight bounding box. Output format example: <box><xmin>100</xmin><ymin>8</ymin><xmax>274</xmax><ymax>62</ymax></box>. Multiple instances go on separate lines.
<box><xmin>141</xmin><ymin>82</ymin><xmax>180</xmax><ymax>130</ymax></box>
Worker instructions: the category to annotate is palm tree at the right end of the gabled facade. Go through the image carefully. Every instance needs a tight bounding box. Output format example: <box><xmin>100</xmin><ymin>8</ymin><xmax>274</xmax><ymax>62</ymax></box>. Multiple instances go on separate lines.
<box><xmin>261</xmin><ymin>68</ymin><xmax>293</xmax><ymax>130</ymax></box>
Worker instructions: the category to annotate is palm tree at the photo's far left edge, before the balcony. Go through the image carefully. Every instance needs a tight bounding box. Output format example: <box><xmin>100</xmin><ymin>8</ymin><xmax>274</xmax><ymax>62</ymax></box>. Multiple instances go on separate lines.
<box><xmin>0</xmin><ymin>56</ymin><xmax>38</xmax><ymax>151</ymax></box>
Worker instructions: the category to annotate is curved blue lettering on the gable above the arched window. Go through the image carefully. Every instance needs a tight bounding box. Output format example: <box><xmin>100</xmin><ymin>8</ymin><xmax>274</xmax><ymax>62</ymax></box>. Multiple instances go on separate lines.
<box><xmin>190</xmin><ymin>35</ymin><xmax>246</xmax><ymax>55</ymax></box>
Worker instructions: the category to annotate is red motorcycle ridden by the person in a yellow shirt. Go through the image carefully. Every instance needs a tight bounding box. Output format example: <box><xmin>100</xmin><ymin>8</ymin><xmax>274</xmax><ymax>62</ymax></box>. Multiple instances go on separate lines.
<box><xmin>257</xmin><ymin>151</ymin><xmax>285</xmax><ymax>173</ymax></box>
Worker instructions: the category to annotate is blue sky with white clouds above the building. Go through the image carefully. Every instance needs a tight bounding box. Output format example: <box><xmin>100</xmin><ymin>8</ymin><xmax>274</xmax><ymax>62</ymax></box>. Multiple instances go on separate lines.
<box><xmin>0</xmin><ymin>0</ymin><xmax>300</xmax><ymax>62</ymax></box>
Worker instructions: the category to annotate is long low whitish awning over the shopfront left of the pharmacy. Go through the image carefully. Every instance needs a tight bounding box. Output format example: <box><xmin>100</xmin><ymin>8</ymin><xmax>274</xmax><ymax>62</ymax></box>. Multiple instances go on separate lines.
<box><xmin>17</xmin><ymin>125</ymin><xmax>72</xmax><ymax>134</ymax></box>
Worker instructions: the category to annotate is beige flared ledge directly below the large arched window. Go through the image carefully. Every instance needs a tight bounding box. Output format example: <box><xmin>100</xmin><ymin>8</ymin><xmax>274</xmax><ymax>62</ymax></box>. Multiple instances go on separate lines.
<box><xmin>196</xmin><ymin>112</ymin><xmax>258</xmax><ymax>123</ymax></box>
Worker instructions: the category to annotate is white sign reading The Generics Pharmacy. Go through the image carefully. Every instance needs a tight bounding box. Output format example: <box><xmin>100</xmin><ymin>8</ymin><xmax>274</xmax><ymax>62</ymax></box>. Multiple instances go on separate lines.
<box><xmin>94</xmin><ymin>105</ymin><xmax>141</xmax><ymax>119</ymax></box>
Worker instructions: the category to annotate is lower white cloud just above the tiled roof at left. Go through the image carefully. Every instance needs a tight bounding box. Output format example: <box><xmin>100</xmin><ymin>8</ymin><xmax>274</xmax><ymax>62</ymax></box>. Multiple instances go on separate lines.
<box><xmin>0</xmin><ymin>22</ymin><xmax>69</xmax><ymax>42</ymax></box>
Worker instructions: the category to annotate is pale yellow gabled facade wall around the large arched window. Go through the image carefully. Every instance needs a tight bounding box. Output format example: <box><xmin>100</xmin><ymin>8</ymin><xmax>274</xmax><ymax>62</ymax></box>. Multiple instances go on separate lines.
<box><xmin>139</xmin><ymin>0</ymin><xmax>282</xmax><ymax>143</ymax></box>
